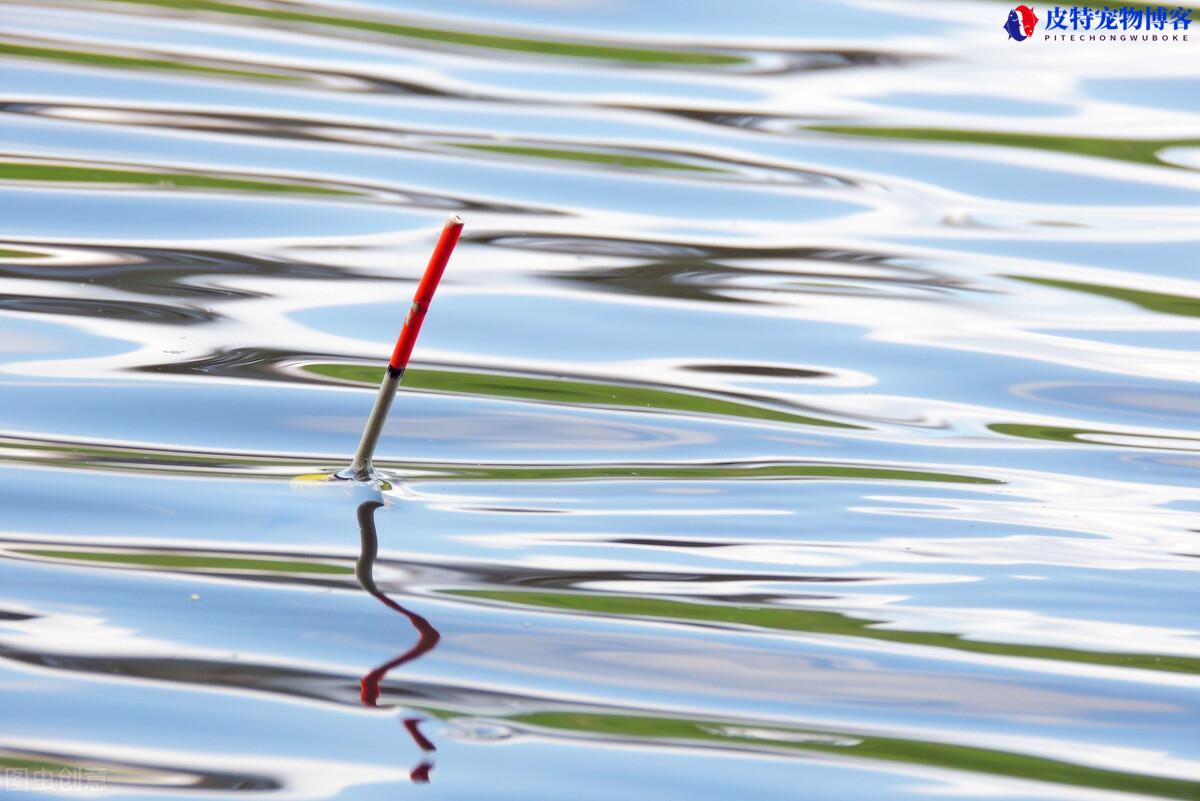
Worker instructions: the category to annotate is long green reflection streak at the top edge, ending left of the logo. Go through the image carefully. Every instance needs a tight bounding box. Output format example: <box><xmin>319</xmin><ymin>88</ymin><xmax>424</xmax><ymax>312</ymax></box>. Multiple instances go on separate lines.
<box><xmin>98</xmin><ymin>0</ymin><xmax>746</xmax><ymax>66</ymax></box>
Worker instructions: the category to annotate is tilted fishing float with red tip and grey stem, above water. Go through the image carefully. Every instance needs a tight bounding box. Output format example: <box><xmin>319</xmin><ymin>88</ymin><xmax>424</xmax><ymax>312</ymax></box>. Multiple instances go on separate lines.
<box><xmin>335</xmin><ymin>215</ymin><xmax>462</xmax><ymax>481</ymax></box>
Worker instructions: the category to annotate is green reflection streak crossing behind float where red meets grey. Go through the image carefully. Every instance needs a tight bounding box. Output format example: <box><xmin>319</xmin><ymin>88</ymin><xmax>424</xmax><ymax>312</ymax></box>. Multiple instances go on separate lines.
<box><xmin>305</xmin><ymin>365</ymin><xmax>862</xmax><ymax>428</ymax></box>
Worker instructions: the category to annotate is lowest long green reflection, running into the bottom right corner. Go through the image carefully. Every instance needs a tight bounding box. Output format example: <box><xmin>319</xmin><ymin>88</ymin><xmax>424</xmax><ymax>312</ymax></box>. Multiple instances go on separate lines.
<box><xmin>506</xmin><ymin>712</ymin><xmax>1200</xmax><ymax>799</ymax></box>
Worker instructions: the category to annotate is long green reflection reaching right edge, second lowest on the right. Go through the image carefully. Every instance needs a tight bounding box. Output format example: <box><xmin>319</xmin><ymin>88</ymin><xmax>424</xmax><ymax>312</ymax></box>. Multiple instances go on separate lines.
<box><xmin>446</xmin><ymin>590</ymin><xmax>1200</xmax><ymax>673</ymax></box>
